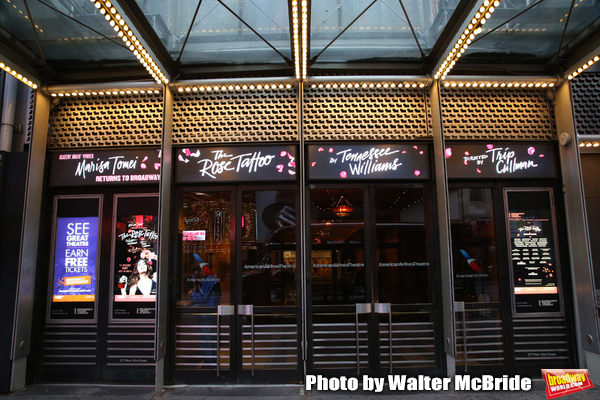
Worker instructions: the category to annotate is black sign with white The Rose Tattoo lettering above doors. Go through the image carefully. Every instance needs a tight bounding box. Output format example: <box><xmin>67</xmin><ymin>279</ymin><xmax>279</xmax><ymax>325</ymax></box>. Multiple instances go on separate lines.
<box><xmin>175</xmin><ymin>145</ymin><xmax>296</xmax><ymax>182</ymax></box>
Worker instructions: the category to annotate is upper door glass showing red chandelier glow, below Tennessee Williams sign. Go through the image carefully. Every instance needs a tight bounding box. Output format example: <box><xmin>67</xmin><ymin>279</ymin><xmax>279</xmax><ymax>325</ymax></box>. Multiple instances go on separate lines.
<box><xmin>310</xmin><ymin>189</ymin><xmax>366</xmax><ymax>304</ymax></box>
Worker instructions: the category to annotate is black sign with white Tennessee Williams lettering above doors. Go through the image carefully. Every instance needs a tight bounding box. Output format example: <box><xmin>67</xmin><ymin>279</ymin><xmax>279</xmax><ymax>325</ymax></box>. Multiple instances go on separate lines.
<box><xmin>308</xmin><ymin>143</ymin><xmax>429</xmax><ymax>180</ymax></box>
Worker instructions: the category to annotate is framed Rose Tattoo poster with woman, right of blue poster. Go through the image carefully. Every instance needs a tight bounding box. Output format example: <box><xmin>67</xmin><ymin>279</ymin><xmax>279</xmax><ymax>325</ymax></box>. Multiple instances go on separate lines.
<box><xmin>111</xmin><ymin>194</ymin><xmax>158</xmax><ymax>322</ymax></box>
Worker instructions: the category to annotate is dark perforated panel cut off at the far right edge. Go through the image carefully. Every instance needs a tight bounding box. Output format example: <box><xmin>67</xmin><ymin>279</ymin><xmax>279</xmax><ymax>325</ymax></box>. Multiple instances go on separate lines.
<box><xmin>571</xmin><ymin>72</ymin><xmax>600</xmax><ymax>135</ymax></box>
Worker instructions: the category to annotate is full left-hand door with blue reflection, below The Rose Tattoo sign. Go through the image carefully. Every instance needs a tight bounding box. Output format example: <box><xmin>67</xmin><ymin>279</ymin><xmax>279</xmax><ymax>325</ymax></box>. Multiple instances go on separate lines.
<box><xmin>174</xmin><ymin>190</ymin><xmax>234</xmax><ymax>377</ymax></box>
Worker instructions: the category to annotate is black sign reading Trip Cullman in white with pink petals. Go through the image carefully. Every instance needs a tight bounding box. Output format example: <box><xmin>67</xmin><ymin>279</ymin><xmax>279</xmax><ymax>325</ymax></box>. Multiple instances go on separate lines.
<box><xmin>445</xmin><ymin>142</ymin><xmax>556</xmax><ymax>179</ymax></box>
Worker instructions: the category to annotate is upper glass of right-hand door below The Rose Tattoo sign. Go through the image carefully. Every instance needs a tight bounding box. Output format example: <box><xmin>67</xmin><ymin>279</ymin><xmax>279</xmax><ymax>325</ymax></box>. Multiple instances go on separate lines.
<box><xmin>240</xmin><ymin>190</ymin><xmax>296</xmax><ymax>306</ymax></box>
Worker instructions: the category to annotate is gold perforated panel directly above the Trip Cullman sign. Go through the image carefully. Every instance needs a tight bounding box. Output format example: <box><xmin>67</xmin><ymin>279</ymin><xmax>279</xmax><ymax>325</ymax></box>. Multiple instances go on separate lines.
<box><xmin>441</xmin><ymin>88</ymin><xmax>556</xmax><ymax>140</ymax></box>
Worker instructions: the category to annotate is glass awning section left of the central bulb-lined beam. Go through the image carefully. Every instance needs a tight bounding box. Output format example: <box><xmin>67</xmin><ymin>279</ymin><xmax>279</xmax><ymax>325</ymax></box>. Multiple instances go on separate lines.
<box><xmin>136</xmin><ymin>0</ymin><xmax>292</xmax><ymax>65</ymax></box>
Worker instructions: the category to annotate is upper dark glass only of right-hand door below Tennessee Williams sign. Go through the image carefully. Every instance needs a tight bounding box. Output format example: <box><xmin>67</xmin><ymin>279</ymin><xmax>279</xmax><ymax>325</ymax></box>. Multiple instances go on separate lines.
<box><xmin>375</xmin><ymin>188</ymin><xmax>434</xmax><ymax>304</ymax></box>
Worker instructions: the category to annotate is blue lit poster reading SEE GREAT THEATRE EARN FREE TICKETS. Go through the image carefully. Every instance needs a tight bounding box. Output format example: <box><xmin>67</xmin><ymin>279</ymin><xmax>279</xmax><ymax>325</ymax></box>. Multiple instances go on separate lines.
<box><xmin>50</xmin><ymin>217</ymin><xmax>98</xmax><ymax>319</ymax></box>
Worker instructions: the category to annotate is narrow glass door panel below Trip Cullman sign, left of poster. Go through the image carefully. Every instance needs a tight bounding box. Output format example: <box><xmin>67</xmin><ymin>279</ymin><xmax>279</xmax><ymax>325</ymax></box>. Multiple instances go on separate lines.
<box><xmin>449</xmin><ymin>187</ymin><xmax>504</xmax><ymax>371</ymax></box>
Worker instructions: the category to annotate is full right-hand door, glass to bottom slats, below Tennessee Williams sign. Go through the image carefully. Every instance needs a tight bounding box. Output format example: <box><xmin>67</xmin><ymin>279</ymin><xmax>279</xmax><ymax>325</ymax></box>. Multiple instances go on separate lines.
<box><xmin>372</xmin><ymin>187</ymin><xmax>436</xmax><ymax>373</ymax></box>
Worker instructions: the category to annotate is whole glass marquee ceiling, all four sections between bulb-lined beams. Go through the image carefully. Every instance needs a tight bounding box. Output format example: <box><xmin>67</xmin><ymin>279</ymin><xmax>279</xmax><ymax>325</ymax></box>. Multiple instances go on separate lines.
<box><xmin>0</xmin><ymin>0</ymin><xmax>600</xmax><ymax>84</ymax></box>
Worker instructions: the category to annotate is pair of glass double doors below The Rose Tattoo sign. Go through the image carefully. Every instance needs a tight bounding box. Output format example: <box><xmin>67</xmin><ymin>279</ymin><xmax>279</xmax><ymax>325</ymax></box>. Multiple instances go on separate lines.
<box><xmin>172</xmin><ymin>186</ymin><xmax>301</xmax><ymax>383</ymax></box>
